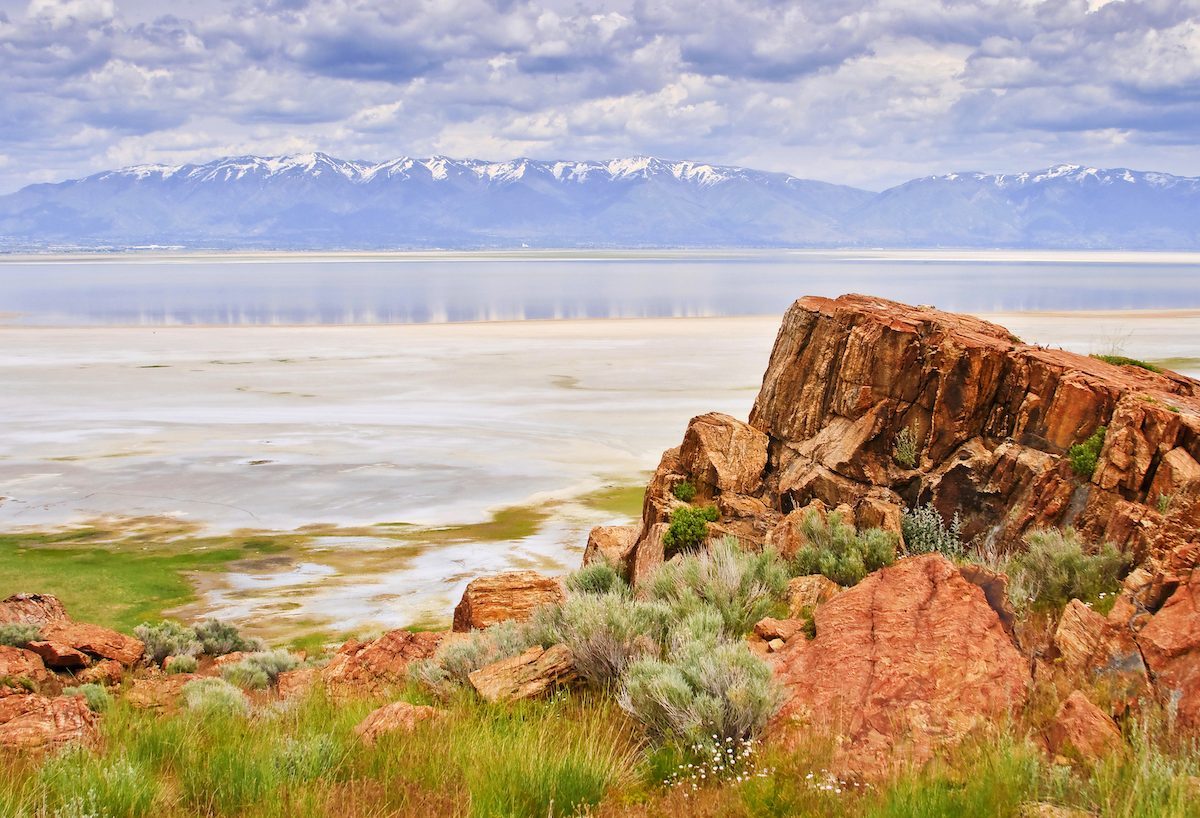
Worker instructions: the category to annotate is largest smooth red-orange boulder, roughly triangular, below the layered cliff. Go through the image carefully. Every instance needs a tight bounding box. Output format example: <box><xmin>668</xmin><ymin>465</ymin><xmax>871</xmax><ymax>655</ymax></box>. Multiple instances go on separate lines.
<box><xmin>774</xmin><ymin>554</ymin><xmax>1030</xmax><ymax>776</ymax></box>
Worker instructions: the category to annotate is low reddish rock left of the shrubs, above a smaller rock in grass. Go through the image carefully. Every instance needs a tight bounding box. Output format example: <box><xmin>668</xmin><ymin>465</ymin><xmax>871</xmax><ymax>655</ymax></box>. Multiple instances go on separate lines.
<box><xmin>320</xmin><ymin>630</ymin><xmax>445</xmax><ymax>694</ymax></box>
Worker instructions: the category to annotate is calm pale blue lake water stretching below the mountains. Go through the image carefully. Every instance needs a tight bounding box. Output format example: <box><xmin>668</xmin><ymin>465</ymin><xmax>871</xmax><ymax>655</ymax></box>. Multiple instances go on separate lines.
<box><xmin>0</xmin><ymin>251</ymin><xmax>1200</xmax><ymax>326</ymax></box>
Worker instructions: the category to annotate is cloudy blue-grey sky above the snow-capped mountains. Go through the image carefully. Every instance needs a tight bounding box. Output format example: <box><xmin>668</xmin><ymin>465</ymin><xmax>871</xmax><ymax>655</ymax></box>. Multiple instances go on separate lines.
<box><xmin>0</xmin><ymin>0</ymin><xmax>1200</xmax><ymax>192</ymax></box>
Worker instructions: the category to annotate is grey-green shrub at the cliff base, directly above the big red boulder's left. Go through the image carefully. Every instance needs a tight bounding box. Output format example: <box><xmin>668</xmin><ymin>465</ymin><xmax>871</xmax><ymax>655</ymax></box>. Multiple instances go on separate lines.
<box><xmin>792</xmin><ymin>511</ymin><xmax>896</xmax><ymax>587</ymax></box>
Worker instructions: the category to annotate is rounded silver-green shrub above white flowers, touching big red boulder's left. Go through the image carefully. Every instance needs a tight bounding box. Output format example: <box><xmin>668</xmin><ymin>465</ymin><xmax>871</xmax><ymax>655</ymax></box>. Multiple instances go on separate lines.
<box><xmin>618</xmin><ymin>637</ymin><xmax>781</xmax><ymax>744</ymax></box>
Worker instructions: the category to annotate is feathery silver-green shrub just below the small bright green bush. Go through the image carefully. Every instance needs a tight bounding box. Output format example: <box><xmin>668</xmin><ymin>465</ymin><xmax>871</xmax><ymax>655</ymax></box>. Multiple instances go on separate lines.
<box><xmin>647</xmin><ymin>537</ymin><xmax>787</xmax><ymax>637</ymax></box>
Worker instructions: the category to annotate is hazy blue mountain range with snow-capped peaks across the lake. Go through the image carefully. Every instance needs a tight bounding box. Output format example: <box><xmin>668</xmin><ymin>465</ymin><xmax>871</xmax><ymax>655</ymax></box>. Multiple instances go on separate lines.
<box><xmin>0</xmin><ymin>154</ymin><xmax>1200</xmax><ymax>251</ymax></box>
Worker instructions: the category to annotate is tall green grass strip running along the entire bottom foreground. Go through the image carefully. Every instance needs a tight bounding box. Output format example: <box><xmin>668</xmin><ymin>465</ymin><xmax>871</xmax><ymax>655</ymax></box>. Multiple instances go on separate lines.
<box><xmin>0</xmin><ymin>691</ymin><xmax>1200</xmax><ymax>818</ymax></box>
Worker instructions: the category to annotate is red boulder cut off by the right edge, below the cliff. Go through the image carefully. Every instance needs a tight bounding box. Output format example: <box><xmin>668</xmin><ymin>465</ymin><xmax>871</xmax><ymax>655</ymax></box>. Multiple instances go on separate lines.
<box><xmin>1138</xmin><ymin>570</ymin><xmax>1200</xmax><ymax>728</ymax></box>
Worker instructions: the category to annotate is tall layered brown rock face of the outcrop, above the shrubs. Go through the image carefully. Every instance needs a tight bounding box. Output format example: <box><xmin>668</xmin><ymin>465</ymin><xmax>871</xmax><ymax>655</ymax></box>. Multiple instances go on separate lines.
<box><xmin>607</xmin><ymin>295</ymin><xmax>1200</xmax><ymax>592</ymax></box>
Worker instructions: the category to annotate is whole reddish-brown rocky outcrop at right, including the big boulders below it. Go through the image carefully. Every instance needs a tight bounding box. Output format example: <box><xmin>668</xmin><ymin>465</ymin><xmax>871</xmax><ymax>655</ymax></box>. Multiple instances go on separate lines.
<box><xmin>584</xmin><ymin>295</ymin><xmax>1200</xmax><ymax>771</ymax></box>
